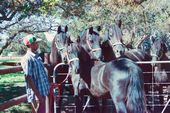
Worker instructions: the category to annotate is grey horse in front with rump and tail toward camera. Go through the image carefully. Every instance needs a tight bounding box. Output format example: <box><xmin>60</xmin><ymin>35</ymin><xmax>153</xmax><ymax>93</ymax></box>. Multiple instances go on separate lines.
<box><xmin>77</xmin><ymin>27</ymin><xmax>147</xmax><ymax>113</ymax></box>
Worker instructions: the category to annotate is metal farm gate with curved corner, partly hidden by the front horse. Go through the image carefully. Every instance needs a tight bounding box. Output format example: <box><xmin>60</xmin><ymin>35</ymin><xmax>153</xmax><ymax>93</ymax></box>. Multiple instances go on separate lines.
<box><xmin>51</xmin><ymin>61</ymin><xmax>170</xmax><ymax>113</ymax></box>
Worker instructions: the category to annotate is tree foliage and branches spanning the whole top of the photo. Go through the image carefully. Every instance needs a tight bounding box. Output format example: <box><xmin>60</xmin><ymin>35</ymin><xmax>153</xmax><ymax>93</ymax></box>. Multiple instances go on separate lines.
<box><xmin>0</xmin><ymin>0</ymin><xmax>169</xmax><ymax>54</ymax></box>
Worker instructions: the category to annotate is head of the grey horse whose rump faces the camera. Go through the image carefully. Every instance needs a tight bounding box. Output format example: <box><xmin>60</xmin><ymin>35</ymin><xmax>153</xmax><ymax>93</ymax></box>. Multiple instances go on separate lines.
<box><xmin>77</xmin><ymin>26</ymin><xmax>102</xmax><ymax>60</ymax></box>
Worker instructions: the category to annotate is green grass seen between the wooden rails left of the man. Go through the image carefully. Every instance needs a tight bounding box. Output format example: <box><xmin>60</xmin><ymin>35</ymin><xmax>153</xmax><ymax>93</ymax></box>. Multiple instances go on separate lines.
<box><xmin>0</xmin><ymin>59</ymin><xmax>31</xmax><ymax>113</ymax></box>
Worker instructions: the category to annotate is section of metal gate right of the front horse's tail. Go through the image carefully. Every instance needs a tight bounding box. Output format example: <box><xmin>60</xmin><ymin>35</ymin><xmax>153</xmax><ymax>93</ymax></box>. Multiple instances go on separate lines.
<box><xmin>137</xmin><ymin>61</ymin><xmax>170</xmax><ymax>113</ymax></box>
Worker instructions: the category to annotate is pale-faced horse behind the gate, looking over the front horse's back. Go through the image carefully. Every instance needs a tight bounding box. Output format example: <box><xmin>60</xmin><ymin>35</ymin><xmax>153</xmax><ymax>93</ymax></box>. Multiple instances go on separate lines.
<box><xmin>103</xmin><ymin>24</ymin><xmax>151</xmax><ymax>61</ymax></box>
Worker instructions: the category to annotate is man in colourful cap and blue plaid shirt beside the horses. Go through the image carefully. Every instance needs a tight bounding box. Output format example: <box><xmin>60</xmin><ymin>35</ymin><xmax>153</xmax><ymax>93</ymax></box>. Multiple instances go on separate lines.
<box><xmin>21</xmin><ymin>35</ymin><xmax>50</xmax><ymax>113</ymax></box>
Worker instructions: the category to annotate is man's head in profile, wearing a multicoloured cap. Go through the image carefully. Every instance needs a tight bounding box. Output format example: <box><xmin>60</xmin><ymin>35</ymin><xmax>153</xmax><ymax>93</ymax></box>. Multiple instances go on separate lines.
<box><xmin>23</xmin><ymin>35</ymin><xmax>41</xmax><ymax>52</ymax></box>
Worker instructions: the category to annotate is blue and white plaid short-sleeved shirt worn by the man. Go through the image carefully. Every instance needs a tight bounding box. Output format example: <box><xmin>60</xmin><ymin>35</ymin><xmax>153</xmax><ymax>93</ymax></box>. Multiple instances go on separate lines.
<box><xmin>21</xmin><ymin>50</ymin><xmax>50</xmax><ymax>102</ymax></box>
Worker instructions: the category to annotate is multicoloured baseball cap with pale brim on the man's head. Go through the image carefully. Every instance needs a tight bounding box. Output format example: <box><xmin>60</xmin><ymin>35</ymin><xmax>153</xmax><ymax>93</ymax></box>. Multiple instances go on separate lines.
<box><xmin>23</xmin><ymin>34</ymin><xmax>42</xmax><ymax>46</ymax></box>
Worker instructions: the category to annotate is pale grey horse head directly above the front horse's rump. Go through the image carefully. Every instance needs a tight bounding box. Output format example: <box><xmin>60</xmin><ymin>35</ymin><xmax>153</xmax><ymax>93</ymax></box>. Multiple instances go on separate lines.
<box><xmin>105</xmin><ymin>24</ymin><xmax>125</xmax><ymax>58</ymax></box>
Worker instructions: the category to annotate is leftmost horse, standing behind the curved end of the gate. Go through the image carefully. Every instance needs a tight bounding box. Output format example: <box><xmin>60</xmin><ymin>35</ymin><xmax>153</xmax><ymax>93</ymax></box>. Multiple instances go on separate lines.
<box><xmin>49</xmin><ymin>26</ymin><xmax>72</xmax><ymax>111</ymax></box>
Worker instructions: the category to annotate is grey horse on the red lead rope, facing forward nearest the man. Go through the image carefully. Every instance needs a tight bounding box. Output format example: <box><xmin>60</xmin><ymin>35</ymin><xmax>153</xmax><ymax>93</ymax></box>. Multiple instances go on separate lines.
<box><xmin>66</xmin><ymin>37</ymin><xmax>92</xmax><ymax>113</ymax></box>
